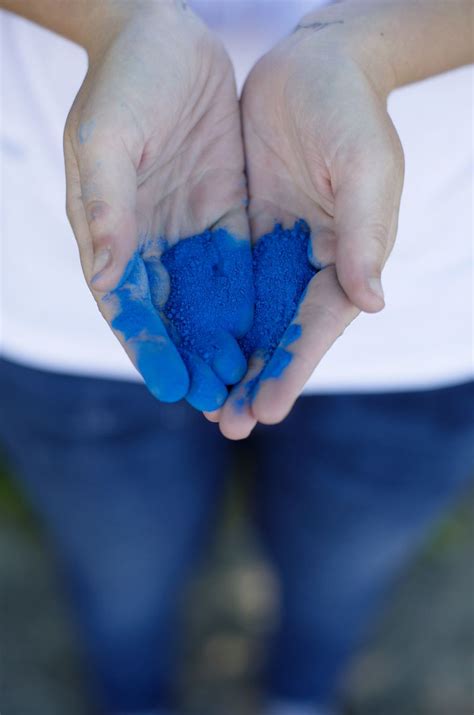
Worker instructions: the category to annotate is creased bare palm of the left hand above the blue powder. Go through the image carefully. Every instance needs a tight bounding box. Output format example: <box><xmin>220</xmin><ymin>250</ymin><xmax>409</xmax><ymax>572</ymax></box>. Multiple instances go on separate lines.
<box><xmin>131</xmin><ymin>37</ymin><xmax>248</xmax><ymax>242</ymax></box>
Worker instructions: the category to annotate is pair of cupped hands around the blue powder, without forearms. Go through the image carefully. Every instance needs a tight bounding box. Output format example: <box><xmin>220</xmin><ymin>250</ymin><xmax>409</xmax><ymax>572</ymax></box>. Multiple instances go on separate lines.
<box><xmin>64</xmin><ymin>0</ymin><xmax>403</xmax><ymax>439</ymax></box>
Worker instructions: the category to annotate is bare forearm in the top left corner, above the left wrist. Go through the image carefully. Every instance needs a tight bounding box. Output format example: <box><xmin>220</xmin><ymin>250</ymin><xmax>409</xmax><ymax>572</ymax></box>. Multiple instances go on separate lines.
<box><xmin>0</xmin><ymin>0</ymin><xmax>178</xmax><ymax>54</ymax></box>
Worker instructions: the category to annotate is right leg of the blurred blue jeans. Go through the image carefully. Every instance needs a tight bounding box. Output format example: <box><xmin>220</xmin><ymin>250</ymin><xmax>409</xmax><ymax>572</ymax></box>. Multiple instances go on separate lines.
<box><xmin>253</xmin><ymin>384</ymin><xmax>474</xmax><ymax>693</ymax></box>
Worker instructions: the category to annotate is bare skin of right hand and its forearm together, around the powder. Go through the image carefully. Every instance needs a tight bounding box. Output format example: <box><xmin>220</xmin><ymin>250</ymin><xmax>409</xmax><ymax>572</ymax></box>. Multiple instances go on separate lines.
<box><xmin>212</xmin><ymin>0</ymin><xmax>473</xmax><ymax>439</ymax></box>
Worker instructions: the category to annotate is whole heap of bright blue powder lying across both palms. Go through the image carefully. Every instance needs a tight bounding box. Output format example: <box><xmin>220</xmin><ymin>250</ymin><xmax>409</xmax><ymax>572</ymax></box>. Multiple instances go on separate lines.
<box><xmin>162</xmin><ymin>220</ymin><xmax>316</xmax><ymax>398</ymax></box>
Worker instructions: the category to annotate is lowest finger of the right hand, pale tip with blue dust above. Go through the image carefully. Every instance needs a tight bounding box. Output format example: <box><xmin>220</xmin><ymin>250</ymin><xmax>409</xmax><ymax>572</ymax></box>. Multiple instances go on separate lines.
<box><xmin>219</xmin><ymin>356</ymin><xmax>264</xmax><ymax>440</ymax></box>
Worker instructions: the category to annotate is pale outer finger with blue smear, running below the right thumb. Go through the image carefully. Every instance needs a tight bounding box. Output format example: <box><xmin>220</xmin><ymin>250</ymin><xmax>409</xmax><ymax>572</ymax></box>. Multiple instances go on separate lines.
<box><xmin>251</xmin><ymin>266</ymin><xmax>359</xmax><ymax>424</ymax></box>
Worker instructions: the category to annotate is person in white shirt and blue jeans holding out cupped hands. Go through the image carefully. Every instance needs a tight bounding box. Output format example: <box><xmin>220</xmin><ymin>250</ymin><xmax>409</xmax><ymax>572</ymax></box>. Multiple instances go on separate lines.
<box><xmin>0</xmin><ymin>0</ymin><xmax>474</xmax><ymax>715</ymax></box>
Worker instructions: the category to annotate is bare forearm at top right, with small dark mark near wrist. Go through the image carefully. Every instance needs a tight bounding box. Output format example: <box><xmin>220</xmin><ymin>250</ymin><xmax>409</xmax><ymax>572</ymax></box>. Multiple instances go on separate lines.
<box><xmin>299</xmin><ymin>0</ymin><xmax>474</xmax><ymax>92</ymax></box>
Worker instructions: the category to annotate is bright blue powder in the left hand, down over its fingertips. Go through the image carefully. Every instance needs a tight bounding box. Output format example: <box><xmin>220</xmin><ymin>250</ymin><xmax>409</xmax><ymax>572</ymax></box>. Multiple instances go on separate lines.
<box><xmin>162</xmin><ymin>229</ymin><xmax>254</xmax><ymax>410</ymax></box>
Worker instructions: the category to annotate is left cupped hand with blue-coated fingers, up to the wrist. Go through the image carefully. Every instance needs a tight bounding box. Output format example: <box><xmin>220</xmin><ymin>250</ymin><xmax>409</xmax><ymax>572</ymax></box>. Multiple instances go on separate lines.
<box><xmin>64</xmin><ymin>1</ymin><xmax>253</xmax><ymax>410</ymax></box>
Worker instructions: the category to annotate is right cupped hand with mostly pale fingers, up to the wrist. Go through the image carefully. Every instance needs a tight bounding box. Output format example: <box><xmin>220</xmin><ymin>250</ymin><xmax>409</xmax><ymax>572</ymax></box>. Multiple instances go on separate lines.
<box><xmin>215</xmin><ymin>9</ymin><xmax>404</xmax><ymax>439</ymax></box>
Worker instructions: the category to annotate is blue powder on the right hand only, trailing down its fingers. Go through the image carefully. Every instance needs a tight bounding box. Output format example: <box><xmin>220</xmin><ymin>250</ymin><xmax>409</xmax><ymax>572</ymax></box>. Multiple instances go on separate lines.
<box><xmin>234</xmin><ymin>219</ymin><xmax>317</xmax><ymax>409</ymax></box>
